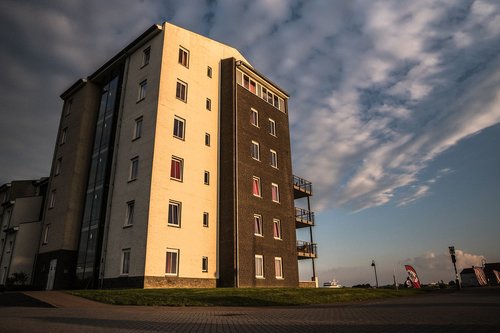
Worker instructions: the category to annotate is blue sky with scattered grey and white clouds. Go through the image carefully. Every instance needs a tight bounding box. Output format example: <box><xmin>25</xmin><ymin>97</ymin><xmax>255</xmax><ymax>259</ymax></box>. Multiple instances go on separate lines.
<box><xmin>0</xmin><ymin>0</ymin><xmax>500</xmax><ymax>286</ymax></box>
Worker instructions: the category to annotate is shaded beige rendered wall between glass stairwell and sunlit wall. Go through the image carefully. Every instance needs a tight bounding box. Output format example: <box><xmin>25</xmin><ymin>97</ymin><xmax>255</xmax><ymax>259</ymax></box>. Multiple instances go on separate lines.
<box><xmin>103</xmin><ymin>28</ymin><xmax>163</xmax><ymax>278</ymax></box>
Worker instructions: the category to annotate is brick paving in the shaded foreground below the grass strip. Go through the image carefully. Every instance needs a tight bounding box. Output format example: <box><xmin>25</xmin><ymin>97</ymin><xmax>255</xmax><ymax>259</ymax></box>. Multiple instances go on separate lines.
<box><xmin>0</xmin><ymin>288</ymin><xmax>500</xmax><ymax>333</ymax></box>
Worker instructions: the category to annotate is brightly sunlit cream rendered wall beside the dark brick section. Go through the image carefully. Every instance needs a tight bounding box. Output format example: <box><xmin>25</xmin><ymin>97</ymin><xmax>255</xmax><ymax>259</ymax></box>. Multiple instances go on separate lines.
<box><xmin>144</xmin><ymin>23</ymin><xmax>245</xmax><ymax>279</ymax></box>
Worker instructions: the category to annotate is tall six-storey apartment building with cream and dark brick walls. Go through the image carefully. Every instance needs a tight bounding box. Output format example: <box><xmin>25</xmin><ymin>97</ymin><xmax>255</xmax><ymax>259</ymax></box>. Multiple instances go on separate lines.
<box><xmin>36</xmin><ymin>23</ymin><xmax>316</xmax><ymax>289</ymax></box>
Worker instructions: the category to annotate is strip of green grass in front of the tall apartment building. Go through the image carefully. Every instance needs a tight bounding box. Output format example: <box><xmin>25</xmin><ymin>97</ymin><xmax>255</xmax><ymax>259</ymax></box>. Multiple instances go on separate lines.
<box><xmin>68</xmin><ymin>288</ymin><xmax>426</xmax><ymax>306</ymax></box>
